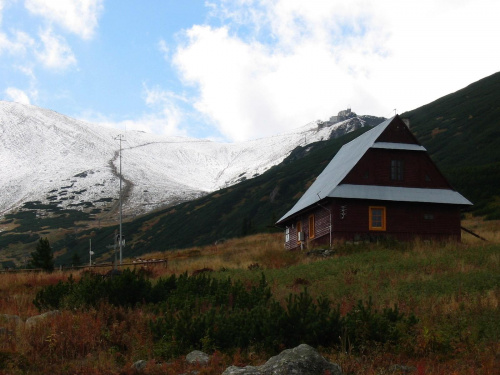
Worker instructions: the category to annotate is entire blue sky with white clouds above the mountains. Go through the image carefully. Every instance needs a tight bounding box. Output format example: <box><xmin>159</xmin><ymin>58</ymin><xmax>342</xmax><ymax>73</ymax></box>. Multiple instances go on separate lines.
<box><xmin>0</xmin><ymin>0</ymin><xmax>500</xmax><ymax>142</ymax></box>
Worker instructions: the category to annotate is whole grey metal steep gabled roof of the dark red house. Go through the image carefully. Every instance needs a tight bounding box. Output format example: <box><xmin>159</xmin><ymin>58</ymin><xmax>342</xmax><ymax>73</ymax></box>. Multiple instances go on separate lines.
<box><xmin>277</xmin><ymin>115</ymin><xmax>472</xmax><ymax>224</ymax></box>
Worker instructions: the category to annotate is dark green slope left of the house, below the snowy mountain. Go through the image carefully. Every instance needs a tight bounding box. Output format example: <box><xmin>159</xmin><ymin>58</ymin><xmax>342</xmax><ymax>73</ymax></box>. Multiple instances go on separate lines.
<box><xmin>54</xmin><ymin>128</ymin><xmax>368</xmax><ymax>263</ymax></box>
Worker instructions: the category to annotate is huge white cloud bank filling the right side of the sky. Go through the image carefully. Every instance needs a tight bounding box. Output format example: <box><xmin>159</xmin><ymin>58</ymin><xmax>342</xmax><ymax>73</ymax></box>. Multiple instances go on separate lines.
<box><xmin>173</xmin><ymin>0</ymin><xmax>500</xmax><ymax>140</ymax></box>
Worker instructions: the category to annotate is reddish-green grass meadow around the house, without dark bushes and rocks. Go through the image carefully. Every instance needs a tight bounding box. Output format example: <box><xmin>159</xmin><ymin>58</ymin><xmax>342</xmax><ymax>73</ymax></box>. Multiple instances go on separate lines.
<box><xmin>0</xmin><ymin>218</ymin><xmax>500</xmax><ymax>375</ymax></box>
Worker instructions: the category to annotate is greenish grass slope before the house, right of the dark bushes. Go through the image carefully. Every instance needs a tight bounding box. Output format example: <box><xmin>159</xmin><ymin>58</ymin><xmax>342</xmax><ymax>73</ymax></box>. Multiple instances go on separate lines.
<box><xmin>216</xmin><ymin>244</ymin><xmax>500</xmax><ymax>353</ymax></box>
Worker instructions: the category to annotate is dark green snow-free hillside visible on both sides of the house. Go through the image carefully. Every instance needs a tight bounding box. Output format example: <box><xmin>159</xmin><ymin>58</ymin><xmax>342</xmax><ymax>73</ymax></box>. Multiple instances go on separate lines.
<box><xmin>0</xmin><ymin>73</ymin><xmax>500</xmax><ymax>264</ymax></box>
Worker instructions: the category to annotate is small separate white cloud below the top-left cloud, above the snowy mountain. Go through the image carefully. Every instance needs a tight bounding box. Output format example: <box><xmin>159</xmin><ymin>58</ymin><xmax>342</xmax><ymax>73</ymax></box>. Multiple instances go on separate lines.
<box><xmin>36</xmin><ymin>28</ymin><xmax>76</xmax><ymax>70</ymax></box>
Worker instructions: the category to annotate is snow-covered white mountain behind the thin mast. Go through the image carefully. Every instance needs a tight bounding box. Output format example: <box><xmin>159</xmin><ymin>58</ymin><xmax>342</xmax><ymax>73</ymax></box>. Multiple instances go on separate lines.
<box><xmin>0</xmin><ymin>101</ymin><xmax>382</xmax><ymax>216</ymax></box>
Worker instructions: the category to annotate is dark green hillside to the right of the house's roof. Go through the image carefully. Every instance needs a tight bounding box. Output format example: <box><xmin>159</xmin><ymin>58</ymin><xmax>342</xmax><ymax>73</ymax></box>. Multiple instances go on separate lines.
<box><xmin>401</xmin><ymin>72</ymin><xmax>500</xmax><ymax>219</ymax></box>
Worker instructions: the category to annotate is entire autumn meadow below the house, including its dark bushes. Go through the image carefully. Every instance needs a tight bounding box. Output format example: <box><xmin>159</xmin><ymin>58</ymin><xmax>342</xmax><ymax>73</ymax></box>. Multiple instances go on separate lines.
<box><xmin>0</xmin><ymin>222</ymin><xmax>500</xmax><ymax>374</ymax></box>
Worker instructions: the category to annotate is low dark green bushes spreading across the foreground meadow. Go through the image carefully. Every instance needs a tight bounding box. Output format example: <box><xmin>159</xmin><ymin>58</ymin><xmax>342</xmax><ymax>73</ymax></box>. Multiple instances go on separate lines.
<box><xmin>34</xmin><ymin>271</ymin><xmax>416</xmax><ymax>358</ymax></box>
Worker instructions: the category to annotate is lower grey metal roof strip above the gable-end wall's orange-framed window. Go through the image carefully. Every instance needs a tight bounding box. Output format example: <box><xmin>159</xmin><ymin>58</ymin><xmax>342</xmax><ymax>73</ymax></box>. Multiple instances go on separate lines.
<box><xmin>328</xmin><ymin>184</ymin><xmax>472</xmax><ymax>205</ymax></box>
